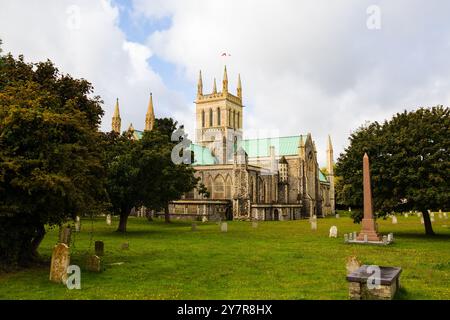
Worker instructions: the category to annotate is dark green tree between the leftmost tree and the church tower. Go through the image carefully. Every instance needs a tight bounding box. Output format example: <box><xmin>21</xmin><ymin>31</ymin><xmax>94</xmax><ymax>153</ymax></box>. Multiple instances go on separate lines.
<box><xmin>106</xmin><ymin>118</ymin><xmax>198</xmax><ymax>232</ymax></box>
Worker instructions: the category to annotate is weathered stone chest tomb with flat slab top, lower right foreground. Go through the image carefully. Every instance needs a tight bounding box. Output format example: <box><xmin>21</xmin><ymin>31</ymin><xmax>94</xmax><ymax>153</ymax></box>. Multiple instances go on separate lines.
<box><xmin>347</xmin><ymin>265</ymin><xmax>402</xmax><ymax>300</ymax></box>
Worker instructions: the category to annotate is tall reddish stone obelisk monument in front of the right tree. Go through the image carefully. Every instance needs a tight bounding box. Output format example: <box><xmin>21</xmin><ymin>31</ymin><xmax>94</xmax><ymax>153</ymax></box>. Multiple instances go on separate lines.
<box><xmin>357</xmin><ymin>153</ymin><xmax>381</xmax><ymax>242</ymax></box>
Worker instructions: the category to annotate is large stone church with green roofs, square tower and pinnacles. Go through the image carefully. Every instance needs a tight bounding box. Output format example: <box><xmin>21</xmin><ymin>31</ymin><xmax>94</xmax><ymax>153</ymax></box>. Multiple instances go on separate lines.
<box><xmin>112</xmin><ymin>67</ymin><xmax>335</xmax><ymax>221</ymax></box>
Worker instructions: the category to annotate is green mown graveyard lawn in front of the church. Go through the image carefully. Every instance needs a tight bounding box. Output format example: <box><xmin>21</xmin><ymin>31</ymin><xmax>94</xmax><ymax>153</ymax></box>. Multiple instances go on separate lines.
<box><xmin>0</xmin><ymin>213</ymin><xmax>450</xmax><ymax>300</ymax></box>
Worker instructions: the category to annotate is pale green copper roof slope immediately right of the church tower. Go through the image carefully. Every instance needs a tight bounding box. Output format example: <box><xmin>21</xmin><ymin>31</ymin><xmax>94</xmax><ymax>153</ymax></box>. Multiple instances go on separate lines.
<box><xmin>242</xmin><ymin>136</ymin><xmax>307</xmax><ymax>158</ymax></box>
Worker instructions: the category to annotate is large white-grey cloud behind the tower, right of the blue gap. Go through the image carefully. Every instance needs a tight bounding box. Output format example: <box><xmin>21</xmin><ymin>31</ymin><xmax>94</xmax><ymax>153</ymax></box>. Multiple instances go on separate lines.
<box><xmin>133</xmin><ymin>0</ymin><xmax>450</xmax><ymax>163</ymax></box>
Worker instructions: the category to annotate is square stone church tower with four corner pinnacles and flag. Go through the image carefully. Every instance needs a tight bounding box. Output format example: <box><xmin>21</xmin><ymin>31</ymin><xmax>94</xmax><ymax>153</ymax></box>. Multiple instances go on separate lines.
<box><xmin>195</xmin><ymin>66</ymin><xmax>243</xmax><ymax>164</ymax></box>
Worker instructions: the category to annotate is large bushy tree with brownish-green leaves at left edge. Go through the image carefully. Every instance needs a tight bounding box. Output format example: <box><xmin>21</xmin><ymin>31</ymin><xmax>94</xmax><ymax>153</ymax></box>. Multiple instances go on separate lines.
<box><xmin>0</xmin><ymin>48</ymin><xmax>106</xmax><ymax>265</ymax></box>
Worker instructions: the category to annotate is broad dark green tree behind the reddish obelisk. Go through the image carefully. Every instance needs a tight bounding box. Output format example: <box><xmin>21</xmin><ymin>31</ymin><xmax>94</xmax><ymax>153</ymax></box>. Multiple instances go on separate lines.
<box><xmin>336</xmin><ymin>106</ymin><xmax>450</xmax><ymax>235</ymax></box>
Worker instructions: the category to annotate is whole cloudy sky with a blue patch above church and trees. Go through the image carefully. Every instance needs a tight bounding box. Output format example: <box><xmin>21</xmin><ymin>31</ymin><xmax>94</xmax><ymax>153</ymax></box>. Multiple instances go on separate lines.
<box><xmin>0</xmin><ymin>0</ymin><xmax>450</xmax><ymax>165</ymax></box>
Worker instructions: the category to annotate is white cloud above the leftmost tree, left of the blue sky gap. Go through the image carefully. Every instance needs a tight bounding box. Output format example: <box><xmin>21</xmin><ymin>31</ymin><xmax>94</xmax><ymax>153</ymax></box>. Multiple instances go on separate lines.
<box><xmin>0</xmin><ymin>0</ymin><xmax>183</xmax><ymax>130</ymax></box>
